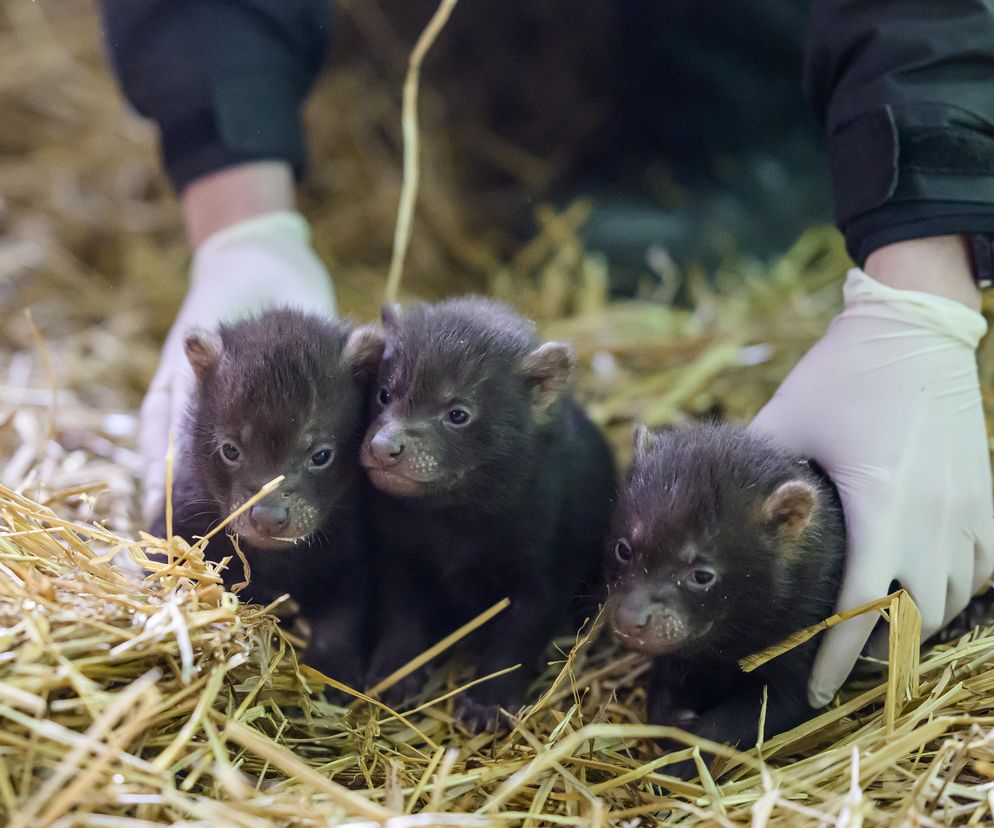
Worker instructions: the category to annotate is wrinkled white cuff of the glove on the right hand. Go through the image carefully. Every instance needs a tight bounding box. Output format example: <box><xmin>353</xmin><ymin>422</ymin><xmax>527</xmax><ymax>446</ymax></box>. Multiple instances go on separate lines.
<box><xmin>843</xmin><ymin>267</ymin><xmax>987</xmax><ymax>350</ymax></box>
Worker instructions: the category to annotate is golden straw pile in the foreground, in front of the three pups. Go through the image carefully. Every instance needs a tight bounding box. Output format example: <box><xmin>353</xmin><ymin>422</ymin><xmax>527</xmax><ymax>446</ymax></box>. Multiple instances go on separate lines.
<box><xmin>0</xmin><ymin>420</ymin><xmax>994</xmax><ymax>828</ymax></box>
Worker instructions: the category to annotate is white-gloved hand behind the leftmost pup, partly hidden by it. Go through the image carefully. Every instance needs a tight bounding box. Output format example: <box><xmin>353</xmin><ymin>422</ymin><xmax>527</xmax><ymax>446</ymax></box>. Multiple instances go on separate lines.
<box><xmin>138</xmin><ymin>211</ymin><xmax>335</xmax><ymax>522</ymax></box>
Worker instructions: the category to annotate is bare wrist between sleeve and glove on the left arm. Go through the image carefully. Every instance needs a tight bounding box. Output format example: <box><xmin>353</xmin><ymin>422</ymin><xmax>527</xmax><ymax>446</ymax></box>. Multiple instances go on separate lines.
<box><xmin>182</xmin><ymin>161</ymin><xmax>295</xmax><ymax>250</ymax></box>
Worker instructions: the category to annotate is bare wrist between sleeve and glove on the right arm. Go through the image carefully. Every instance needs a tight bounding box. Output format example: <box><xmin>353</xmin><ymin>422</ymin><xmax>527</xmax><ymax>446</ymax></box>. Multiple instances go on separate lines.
<box><xmin>863</xmin><ymin>236</ymin><xmax>980</xmax><ymax>311</ymax></box>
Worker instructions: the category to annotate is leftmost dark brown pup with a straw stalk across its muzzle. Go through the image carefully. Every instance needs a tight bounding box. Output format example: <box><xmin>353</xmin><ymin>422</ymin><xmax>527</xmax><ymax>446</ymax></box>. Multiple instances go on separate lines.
<box><xmin>153</xmin><ymin>310</ymin><xmax>383</xmax><ymax>685</ymax></box>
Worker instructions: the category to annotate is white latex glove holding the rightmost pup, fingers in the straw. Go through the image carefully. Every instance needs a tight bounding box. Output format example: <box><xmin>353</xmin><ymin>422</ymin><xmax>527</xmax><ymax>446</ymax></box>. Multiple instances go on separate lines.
<box><xmin>750</xmin><ymin>269</ymin><xmax>994</xmax><ymax>707</ymax></box>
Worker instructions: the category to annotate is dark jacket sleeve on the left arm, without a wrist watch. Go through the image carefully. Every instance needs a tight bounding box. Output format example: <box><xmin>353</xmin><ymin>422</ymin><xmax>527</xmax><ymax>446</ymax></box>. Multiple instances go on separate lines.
<box><xmin>100</xmin><ymin>0</ymin><xmax>331</xmax><ymax>192</ymax></box>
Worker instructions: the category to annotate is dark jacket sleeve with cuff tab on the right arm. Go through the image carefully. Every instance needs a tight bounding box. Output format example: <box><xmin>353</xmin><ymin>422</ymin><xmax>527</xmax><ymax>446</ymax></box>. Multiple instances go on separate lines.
<box><xmin>805</xmin><ymin>0</ymin><xmax>994</xmax><ymax>264</ymax></box>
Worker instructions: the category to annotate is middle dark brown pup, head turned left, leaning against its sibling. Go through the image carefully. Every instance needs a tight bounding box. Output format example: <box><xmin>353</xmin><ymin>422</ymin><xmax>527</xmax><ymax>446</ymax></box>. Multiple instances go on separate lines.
<box><xmin>362</xmin><ymin>298</ymin><xmax>614</xmax><ymax>730</ymax></box>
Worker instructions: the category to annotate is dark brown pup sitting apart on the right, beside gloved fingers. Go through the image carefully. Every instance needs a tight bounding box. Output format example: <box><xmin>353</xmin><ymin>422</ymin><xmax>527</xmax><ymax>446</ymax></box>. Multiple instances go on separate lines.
<box><xmin>606</xmin><ymin>425</ymin><xmax>845</xmax><ymax>776</ymax></box>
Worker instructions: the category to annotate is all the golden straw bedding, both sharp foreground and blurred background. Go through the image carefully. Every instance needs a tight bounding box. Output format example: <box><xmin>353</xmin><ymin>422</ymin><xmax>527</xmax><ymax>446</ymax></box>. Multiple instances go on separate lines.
<box><xmin>0</xmin><ymin>0</ymin><xmax>994</xmax><ymax>828</ymax></box>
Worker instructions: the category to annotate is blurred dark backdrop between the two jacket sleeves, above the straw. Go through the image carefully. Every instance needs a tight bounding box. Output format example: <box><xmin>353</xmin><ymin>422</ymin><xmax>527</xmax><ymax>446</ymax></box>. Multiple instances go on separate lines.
<box><xmin>306</xmin><ymin>0</ymin><xmax>830</xmax><ymax>295</ymax></box>
